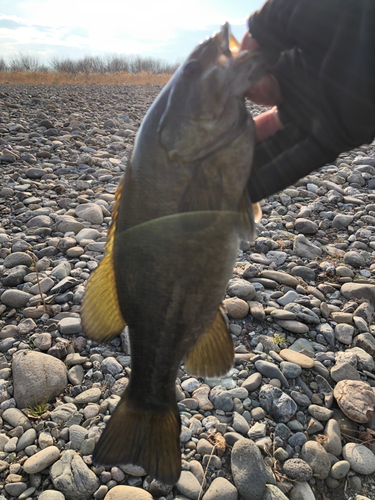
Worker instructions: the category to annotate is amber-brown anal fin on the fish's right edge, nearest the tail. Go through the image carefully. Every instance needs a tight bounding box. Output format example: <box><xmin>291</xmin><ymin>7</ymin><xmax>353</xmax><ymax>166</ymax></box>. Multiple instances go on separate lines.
<box><xmin>185</xmin><ymin>309</ymin><xmax>234</xmax><ymax>378</ymax></box>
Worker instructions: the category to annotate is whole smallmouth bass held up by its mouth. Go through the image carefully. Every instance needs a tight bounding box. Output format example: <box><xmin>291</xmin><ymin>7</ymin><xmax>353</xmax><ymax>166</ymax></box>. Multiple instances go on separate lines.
<box><xmin>81</xmin><ymin>24</ymin><xmax>266</xmax><ymax>484</ymax></box>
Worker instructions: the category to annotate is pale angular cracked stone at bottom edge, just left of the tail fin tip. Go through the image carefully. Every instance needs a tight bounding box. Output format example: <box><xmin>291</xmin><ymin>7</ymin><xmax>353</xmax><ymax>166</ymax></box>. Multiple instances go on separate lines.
<box><xmin>51</xmin><ymin>448</ymin><xmax>100</xmax><ymax>500</ymax></box>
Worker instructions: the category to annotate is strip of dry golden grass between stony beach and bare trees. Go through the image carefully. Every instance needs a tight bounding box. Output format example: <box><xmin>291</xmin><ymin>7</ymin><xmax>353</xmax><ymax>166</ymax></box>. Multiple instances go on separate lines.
<box><xmin>0</xmin><ymin>71</ymin><xmax>172</xmax><ymax>85</ymax></box>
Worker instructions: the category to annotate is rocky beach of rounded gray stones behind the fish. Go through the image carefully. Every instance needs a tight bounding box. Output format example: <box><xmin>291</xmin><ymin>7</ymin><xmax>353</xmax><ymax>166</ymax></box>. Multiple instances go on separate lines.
<box><xmin>0</xmin><ymin>84</ymin><xmax>375</xmax><ymax>500</ymax></box>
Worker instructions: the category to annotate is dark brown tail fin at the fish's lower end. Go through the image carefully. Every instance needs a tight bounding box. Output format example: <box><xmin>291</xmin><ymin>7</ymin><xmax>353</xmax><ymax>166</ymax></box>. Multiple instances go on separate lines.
<box><xmin>92</xmin><ymin>391</ymin><xmax>181</xmax><ymax>484</ymax></box>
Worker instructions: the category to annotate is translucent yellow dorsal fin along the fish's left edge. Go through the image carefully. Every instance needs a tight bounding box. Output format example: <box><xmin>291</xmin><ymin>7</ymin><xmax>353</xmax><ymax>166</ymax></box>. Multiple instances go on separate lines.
<box><xmin>81</xmin><ymin>184</ymin><xmax>126</xmax><ymax>341</ymax></box>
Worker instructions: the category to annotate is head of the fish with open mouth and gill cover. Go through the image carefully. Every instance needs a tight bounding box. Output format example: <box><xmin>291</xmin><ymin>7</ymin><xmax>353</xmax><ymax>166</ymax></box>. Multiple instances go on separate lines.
<box><xmin>158</xmin><ymin>23</ymin><xmax>267</xmax><ymax>162</ymax></box>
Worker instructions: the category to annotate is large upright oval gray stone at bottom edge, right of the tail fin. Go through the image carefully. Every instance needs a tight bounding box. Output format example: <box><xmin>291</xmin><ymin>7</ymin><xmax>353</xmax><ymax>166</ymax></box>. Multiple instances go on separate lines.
<box><xmin>231</xmin><ymin>439</ymin><xmax>267</xmax><ymax>500</ymax></box>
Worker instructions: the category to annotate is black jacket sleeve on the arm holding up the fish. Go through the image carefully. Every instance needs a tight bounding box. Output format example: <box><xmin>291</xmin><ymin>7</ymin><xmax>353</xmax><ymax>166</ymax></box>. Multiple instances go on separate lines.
<box><xmin>248</xmin><ymin>0</ymin><xmax>375</xmax><ymax>202</ymax></box>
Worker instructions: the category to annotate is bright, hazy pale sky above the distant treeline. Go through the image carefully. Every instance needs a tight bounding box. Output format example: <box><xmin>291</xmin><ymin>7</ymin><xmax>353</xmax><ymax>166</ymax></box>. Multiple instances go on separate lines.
<box><xmin>0</xmin><ymin>0</ymin><xmax>263</xmax><ymax>63</ymax></box>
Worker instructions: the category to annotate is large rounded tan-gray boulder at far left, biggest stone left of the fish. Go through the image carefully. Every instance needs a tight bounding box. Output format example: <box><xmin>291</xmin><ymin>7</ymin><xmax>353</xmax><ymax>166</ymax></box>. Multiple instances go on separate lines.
<box><xmin>12</xmin><ymin>351</ymin><xmax>68</xmax><ymax>408</ymax></box>
